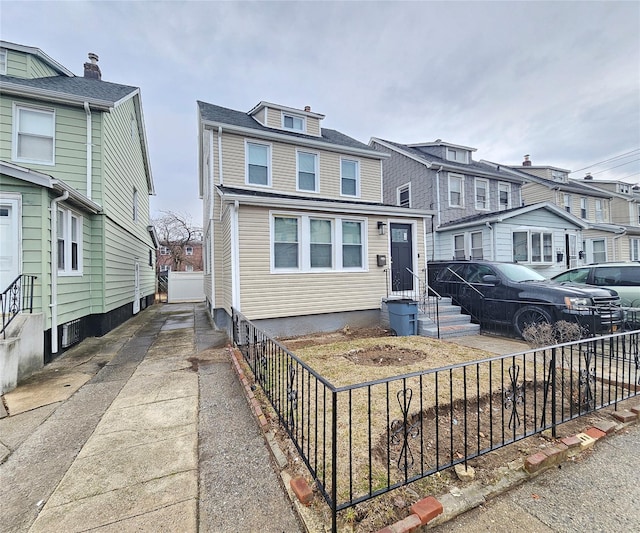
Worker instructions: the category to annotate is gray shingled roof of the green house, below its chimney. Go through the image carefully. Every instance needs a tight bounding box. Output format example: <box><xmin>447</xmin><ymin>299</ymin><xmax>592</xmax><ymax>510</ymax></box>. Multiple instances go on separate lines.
<box><xmin>0</xmin><ymin>75</ymin><xmax>138</xmax><ymax>102</ymax></box>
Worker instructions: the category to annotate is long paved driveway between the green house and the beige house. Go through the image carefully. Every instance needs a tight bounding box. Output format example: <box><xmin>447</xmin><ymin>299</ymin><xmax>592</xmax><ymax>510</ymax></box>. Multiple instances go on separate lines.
<box><xmin>0</xmin><ymin>304</ymin><xmax>301</xmax><ymax>532</ymax></box>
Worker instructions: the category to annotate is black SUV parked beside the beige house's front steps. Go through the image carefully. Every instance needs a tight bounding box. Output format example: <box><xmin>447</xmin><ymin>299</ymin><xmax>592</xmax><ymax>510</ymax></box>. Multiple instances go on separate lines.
<box><xmin>427</xmin><ymin>260</ymin><xmax>623</xmax><ymax>336</ymax></box>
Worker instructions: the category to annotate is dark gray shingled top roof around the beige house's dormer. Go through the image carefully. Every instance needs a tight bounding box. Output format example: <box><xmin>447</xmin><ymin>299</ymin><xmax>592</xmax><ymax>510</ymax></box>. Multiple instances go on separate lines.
<box><xmin>198</xmin><ymin>101</ymin><xmax>373</xmax><ymax>152</ymax></box>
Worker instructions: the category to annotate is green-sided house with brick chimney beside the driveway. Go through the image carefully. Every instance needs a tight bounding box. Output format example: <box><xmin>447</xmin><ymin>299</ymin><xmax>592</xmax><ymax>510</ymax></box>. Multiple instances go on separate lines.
<box><xmin>0</xmin><ymin>41</ymin><xmax>157</xmax><ymax>370</ymax></box>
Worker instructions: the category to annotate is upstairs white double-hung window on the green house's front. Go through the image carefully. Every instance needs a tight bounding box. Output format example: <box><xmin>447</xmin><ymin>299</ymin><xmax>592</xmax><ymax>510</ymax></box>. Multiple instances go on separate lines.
<box><xmin>13</xmin><ymin>106</ymin><xmax>55</xmax><ymax>165</ymax></box>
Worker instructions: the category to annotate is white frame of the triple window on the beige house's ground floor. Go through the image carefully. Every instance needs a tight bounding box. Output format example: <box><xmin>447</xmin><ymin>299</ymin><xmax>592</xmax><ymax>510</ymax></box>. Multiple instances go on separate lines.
<box><xmin>269</xmin><ymin>211</ymin><xmax>369</xmax><ymax>274</ymax></box>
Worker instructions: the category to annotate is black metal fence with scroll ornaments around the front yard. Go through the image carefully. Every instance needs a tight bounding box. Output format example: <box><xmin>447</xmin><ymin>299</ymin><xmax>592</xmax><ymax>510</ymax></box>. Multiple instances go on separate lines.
<box><xmin>233</xmin><ymin>310</ymin><xmax>640</xmax><ymax>531</ymax></box>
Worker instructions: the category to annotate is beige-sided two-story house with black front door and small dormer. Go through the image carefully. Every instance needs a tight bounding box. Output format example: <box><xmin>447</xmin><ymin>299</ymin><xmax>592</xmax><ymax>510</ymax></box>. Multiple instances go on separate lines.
<box><xmin>198</xmin><ymin>102</ymin><xmax>434</xmax><ymax>335</ymax></box>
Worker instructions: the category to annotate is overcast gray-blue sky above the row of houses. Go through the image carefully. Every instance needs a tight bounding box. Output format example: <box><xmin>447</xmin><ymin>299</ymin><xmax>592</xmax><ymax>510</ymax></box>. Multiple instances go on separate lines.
<box><xmin>0</xmin><ymin>0</ymin><xmax>640</xmax><ymax>225</ymax></box>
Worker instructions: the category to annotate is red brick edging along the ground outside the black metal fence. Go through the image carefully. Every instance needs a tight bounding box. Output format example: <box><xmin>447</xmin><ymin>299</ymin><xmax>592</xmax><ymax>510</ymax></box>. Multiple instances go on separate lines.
<box><xmin>228</xmin><ymin>345</ymin><xmax>640</xmax><ymax>533</ymax></box>
